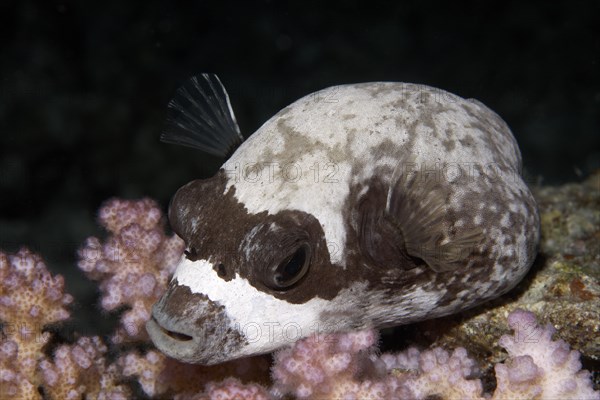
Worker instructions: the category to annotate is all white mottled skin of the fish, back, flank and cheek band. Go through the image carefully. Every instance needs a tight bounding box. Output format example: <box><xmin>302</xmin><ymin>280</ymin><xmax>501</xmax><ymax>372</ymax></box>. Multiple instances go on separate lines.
<box><xmin>150</xmin><ymin>83</ymin><xmax>538</xmax><ymax>362</ymax></box>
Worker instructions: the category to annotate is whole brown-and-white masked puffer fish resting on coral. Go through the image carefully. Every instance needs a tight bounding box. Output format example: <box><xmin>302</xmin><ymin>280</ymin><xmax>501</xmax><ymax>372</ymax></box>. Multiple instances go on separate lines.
<box><xmin>147</xmin><ymin>74</ymin><xmax>539</xmax><ymax>365</ymax></box>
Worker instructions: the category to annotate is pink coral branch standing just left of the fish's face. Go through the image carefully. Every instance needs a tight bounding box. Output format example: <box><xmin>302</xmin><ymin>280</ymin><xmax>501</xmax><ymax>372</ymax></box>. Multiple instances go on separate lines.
<box><xmin>78</xmin><ymin>199</ymin><xmax>184</xmax><ymax>342</ymax></box>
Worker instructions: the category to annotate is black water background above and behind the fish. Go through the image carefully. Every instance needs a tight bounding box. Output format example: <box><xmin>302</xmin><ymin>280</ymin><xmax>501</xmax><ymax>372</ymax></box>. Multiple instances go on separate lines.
<box><xmin>0</xmin><ymin>0</ymin><xmax>600</xmax><ymax>310</ymax></box>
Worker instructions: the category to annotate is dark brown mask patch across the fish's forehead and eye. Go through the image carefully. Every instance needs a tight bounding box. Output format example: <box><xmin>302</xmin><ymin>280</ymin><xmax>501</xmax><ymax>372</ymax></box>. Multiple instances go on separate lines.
<box><xmin>169</xmin><ymin>170</ymin><xmax>346</xmax><ymax>304</ymax></box>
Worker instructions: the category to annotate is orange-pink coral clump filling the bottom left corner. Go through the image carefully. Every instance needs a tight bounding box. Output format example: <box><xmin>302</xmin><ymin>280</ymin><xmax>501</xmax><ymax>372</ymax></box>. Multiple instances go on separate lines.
<box><xmin>0</xmin><ymin>249</ymin><xmax>131</xmax><ymax>400</ymax></box>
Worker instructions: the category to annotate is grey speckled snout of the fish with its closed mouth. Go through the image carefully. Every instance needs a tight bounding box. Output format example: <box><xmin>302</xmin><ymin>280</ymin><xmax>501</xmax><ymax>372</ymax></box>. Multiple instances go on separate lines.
<box><xmin>146</xmin><ymin>280</ymin><xmax>248</xmax><ymax>365</ymax></box>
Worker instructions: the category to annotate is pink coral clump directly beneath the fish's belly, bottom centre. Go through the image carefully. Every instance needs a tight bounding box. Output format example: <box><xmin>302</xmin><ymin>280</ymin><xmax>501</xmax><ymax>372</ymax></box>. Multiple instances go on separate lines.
<box><xmin>273</xmin><ymin>330</ymin><xmax>482</xmax><ymax>399</ymax></box>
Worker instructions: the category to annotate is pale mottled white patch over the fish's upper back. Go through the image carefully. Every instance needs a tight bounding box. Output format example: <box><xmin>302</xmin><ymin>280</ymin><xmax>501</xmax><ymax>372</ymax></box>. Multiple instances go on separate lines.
<box><xmin>223</xmin><ymin>82</ymin><xmax>526</xmax><ymax>265</ymax></box>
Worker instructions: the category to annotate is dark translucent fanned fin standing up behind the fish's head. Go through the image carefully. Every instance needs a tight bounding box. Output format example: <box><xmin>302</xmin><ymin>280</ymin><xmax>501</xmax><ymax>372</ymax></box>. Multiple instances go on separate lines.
<box><xmin>160</xmin><ymin>74</ymin><xmax>244</xmax><ymax>158</ymax></box>
